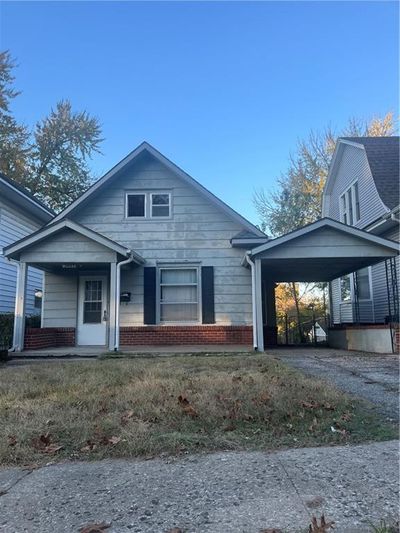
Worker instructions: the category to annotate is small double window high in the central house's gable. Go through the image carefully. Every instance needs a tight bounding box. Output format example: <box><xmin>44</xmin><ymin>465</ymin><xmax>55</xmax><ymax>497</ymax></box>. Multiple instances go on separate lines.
<box><xmin>125</xmin><ymin>191</ymin><xmax>171</xmax><ymax>220</ymax></box>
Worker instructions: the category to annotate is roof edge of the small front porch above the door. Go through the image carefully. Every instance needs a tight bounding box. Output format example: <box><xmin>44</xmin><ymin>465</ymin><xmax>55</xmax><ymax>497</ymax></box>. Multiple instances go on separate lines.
<box><xmin>3</xmin><ymin>219</ymin><xmax>145</xmax><ymax>264</ymax></box>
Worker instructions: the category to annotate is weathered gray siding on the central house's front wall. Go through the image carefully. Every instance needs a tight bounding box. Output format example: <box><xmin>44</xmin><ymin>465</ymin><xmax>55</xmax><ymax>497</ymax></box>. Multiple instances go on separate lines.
<box><xmin>72</xmin><ymin>159</ymin><xmax>252</xmax><ymax>325</ymax></box>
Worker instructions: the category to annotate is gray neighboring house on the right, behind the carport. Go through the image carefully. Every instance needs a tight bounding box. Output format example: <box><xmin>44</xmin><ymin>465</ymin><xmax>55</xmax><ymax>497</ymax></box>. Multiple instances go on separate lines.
<box><xmin>323</xmin><ymin>137</ymin><xmax>400</xmax><ymax>351</ymax></box>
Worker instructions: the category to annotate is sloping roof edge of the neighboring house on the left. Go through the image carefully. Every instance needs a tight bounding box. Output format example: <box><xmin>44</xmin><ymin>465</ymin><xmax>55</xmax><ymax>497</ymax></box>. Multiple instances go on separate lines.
<box><xmin>0</xmin><ymin>172</ymin><xmax>55</xmax><ymax>223</ymax></box>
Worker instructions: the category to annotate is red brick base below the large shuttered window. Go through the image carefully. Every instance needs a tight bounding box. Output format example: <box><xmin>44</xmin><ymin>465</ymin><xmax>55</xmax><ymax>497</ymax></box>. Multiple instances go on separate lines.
<box><xmin>120</xmin><ymin>326</ymin><xmax>253</xmax><ymax>346</ymax></box>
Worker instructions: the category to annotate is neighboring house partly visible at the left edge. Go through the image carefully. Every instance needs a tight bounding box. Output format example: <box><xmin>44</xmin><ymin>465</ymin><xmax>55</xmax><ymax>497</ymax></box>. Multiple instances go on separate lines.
<box><xmin>0</xmin><ymin>173</ymin><xmax>54</xmax><ymax>315</ymax></box>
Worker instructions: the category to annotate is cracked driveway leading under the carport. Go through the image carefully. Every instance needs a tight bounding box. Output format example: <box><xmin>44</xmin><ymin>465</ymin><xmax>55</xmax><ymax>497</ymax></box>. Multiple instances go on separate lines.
<box><xmin>274</xmin><ymin>347</ymin><xmax>399</xmax><ymax>421</ymax></box>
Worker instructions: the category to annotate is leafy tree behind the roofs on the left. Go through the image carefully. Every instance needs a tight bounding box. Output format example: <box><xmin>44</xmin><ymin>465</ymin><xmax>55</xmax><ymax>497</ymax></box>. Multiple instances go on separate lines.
<box><xmin>0</xmin><ymin>52</ymin><xmax>102</xmax><ymax>211</ymax></box>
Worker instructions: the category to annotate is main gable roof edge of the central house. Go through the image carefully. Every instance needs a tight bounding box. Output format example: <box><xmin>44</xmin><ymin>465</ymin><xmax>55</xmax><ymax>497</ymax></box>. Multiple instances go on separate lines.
<box><xmin>49</xmin><ymin>142</ymin><xmax>265</xmax><ymax>237</ymax></box>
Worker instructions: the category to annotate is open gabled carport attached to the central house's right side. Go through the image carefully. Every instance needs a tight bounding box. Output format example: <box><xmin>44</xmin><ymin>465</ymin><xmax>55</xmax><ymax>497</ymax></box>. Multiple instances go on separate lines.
<box><xmin>243</xmin><ymin>218</ymin><xmax>399</xmax><ymax>351</ymax></box>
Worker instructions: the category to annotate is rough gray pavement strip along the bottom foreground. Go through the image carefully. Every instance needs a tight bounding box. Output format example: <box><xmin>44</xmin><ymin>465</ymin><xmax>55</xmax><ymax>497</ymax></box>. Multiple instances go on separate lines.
<box><xmin>0</xmin><ymin>441</ymin><xmax>398</xmax><ymax>533</ymax></box>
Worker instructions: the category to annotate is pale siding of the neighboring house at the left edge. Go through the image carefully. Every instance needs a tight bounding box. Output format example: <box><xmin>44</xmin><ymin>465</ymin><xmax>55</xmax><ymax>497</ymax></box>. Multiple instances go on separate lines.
<box><xmin>0</xmin><ymin>200</ymin><xmax>43</xmax><ymax>315</ymax></box>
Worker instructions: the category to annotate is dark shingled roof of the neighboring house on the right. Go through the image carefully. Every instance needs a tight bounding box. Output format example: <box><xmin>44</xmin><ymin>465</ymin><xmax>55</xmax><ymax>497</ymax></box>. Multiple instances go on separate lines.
<box><xmin>342</xmin><ymin>137</ymin><xmax>400</xmax><ymax>209</ymax></box>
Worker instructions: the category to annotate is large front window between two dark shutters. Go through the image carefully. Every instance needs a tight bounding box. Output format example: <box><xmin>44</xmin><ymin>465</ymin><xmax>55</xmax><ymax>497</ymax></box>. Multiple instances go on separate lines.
<box><xmin>160</xmin><ymin>268</ymin><xmax>199</xmax><ymax>323</ymax></box>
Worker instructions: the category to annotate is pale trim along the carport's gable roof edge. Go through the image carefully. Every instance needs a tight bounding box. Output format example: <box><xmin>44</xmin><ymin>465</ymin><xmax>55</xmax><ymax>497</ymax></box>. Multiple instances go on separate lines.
<box><xmin>248</xmin><ymin>218</ymin><xmax>399</xmax><ymax>257</ymax></box>
